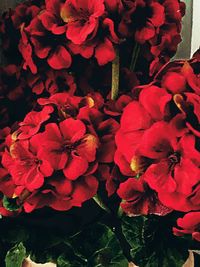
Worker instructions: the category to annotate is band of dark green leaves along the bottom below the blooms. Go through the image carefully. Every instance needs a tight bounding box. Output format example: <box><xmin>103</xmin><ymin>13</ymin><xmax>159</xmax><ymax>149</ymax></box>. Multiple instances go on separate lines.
<box><xmin>0</xmin><ymin>209</ymin><xmax>198</xmax><ymax>267</ymax></box>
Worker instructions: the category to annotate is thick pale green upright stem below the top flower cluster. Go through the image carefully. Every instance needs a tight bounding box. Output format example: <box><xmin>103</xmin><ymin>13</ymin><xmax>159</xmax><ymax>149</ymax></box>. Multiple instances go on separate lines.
<box><xmin>111</xmin><ymin>48</ymin><xmax>120</xmax><ymax>100</ymax></box>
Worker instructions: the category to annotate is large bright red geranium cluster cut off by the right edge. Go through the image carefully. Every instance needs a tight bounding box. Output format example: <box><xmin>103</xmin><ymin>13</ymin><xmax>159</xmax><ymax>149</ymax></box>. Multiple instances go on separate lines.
<box><xmin>115</xmin><ymin>56</ymin><xmax>200</xmax><ymax>241</ymax></box>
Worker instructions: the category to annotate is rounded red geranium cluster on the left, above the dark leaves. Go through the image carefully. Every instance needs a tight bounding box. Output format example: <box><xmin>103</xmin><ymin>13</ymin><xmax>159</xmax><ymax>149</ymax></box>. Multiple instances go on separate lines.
<box><xmin>0</xmin><ymin>93</ymin><xmax>119</xmax><ymax>212</ymax></box>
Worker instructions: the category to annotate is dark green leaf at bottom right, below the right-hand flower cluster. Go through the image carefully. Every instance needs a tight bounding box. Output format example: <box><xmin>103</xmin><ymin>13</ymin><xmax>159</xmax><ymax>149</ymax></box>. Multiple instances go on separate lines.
<box><xmin>122</xmin><ymin>215</ymin><xmax>188</xmax><ymax>267</ymax></box>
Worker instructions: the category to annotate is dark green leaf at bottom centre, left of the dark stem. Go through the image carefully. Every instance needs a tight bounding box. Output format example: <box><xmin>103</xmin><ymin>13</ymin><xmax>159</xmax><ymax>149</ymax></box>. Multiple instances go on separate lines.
<box><xmin>58</xmin><ymin>223</ymin><xmax>128</xmax><ymax>267</ymax></box>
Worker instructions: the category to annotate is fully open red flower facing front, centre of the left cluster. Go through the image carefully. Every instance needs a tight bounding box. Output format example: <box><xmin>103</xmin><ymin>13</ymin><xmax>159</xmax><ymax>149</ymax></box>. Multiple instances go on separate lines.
<box><xmin>34</xmin><ymin>118</ymin><xmax>98</xmax><ymax>180</ymax></box>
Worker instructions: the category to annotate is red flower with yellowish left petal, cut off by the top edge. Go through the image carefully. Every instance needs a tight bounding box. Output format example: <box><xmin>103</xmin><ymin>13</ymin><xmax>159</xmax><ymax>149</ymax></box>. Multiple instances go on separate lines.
<box><xmin>61</xmin><ymin>0</ymin><xmax>105</xmax><ymax>45</ymax></box>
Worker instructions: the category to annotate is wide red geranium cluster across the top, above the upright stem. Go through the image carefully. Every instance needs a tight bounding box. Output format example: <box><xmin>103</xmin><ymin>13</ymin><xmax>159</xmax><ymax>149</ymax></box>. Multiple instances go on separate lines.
<box><xmin>0</xmin><ymin>0</ymin><xmax>185</xmax><ymax>74</ymax></box>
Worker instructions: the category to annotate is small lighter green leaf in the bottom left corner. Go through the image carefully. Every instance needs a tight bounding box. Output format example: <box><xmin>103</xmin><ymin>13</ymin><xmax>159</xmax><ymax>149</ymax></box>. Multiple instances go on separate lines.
<box><xmin>5</xmin><ymin>243</ymin><xmax>26</xmax><ymax>267</ymax></box>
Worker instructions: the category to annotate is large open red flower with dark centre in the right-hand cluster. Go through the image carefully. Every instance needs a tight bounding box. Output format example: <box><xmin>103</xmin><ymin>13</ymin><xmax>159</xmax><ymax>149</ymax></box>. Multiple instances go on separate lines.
<box><xmin>141</xmin><ymin>122</ymin><xmax>200</xmax><ymax>214</ymax></box>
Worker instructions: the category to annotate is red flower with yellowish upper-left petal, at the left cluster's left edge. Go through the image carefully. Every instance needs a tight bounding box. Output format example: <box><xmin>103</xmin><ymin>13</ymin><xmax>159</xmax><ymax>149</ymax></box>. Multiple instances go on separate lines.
<box><xmin>2</xmin><ymin>140</ymin><xmax>53</xmax><ymax>192</ymax></box>
